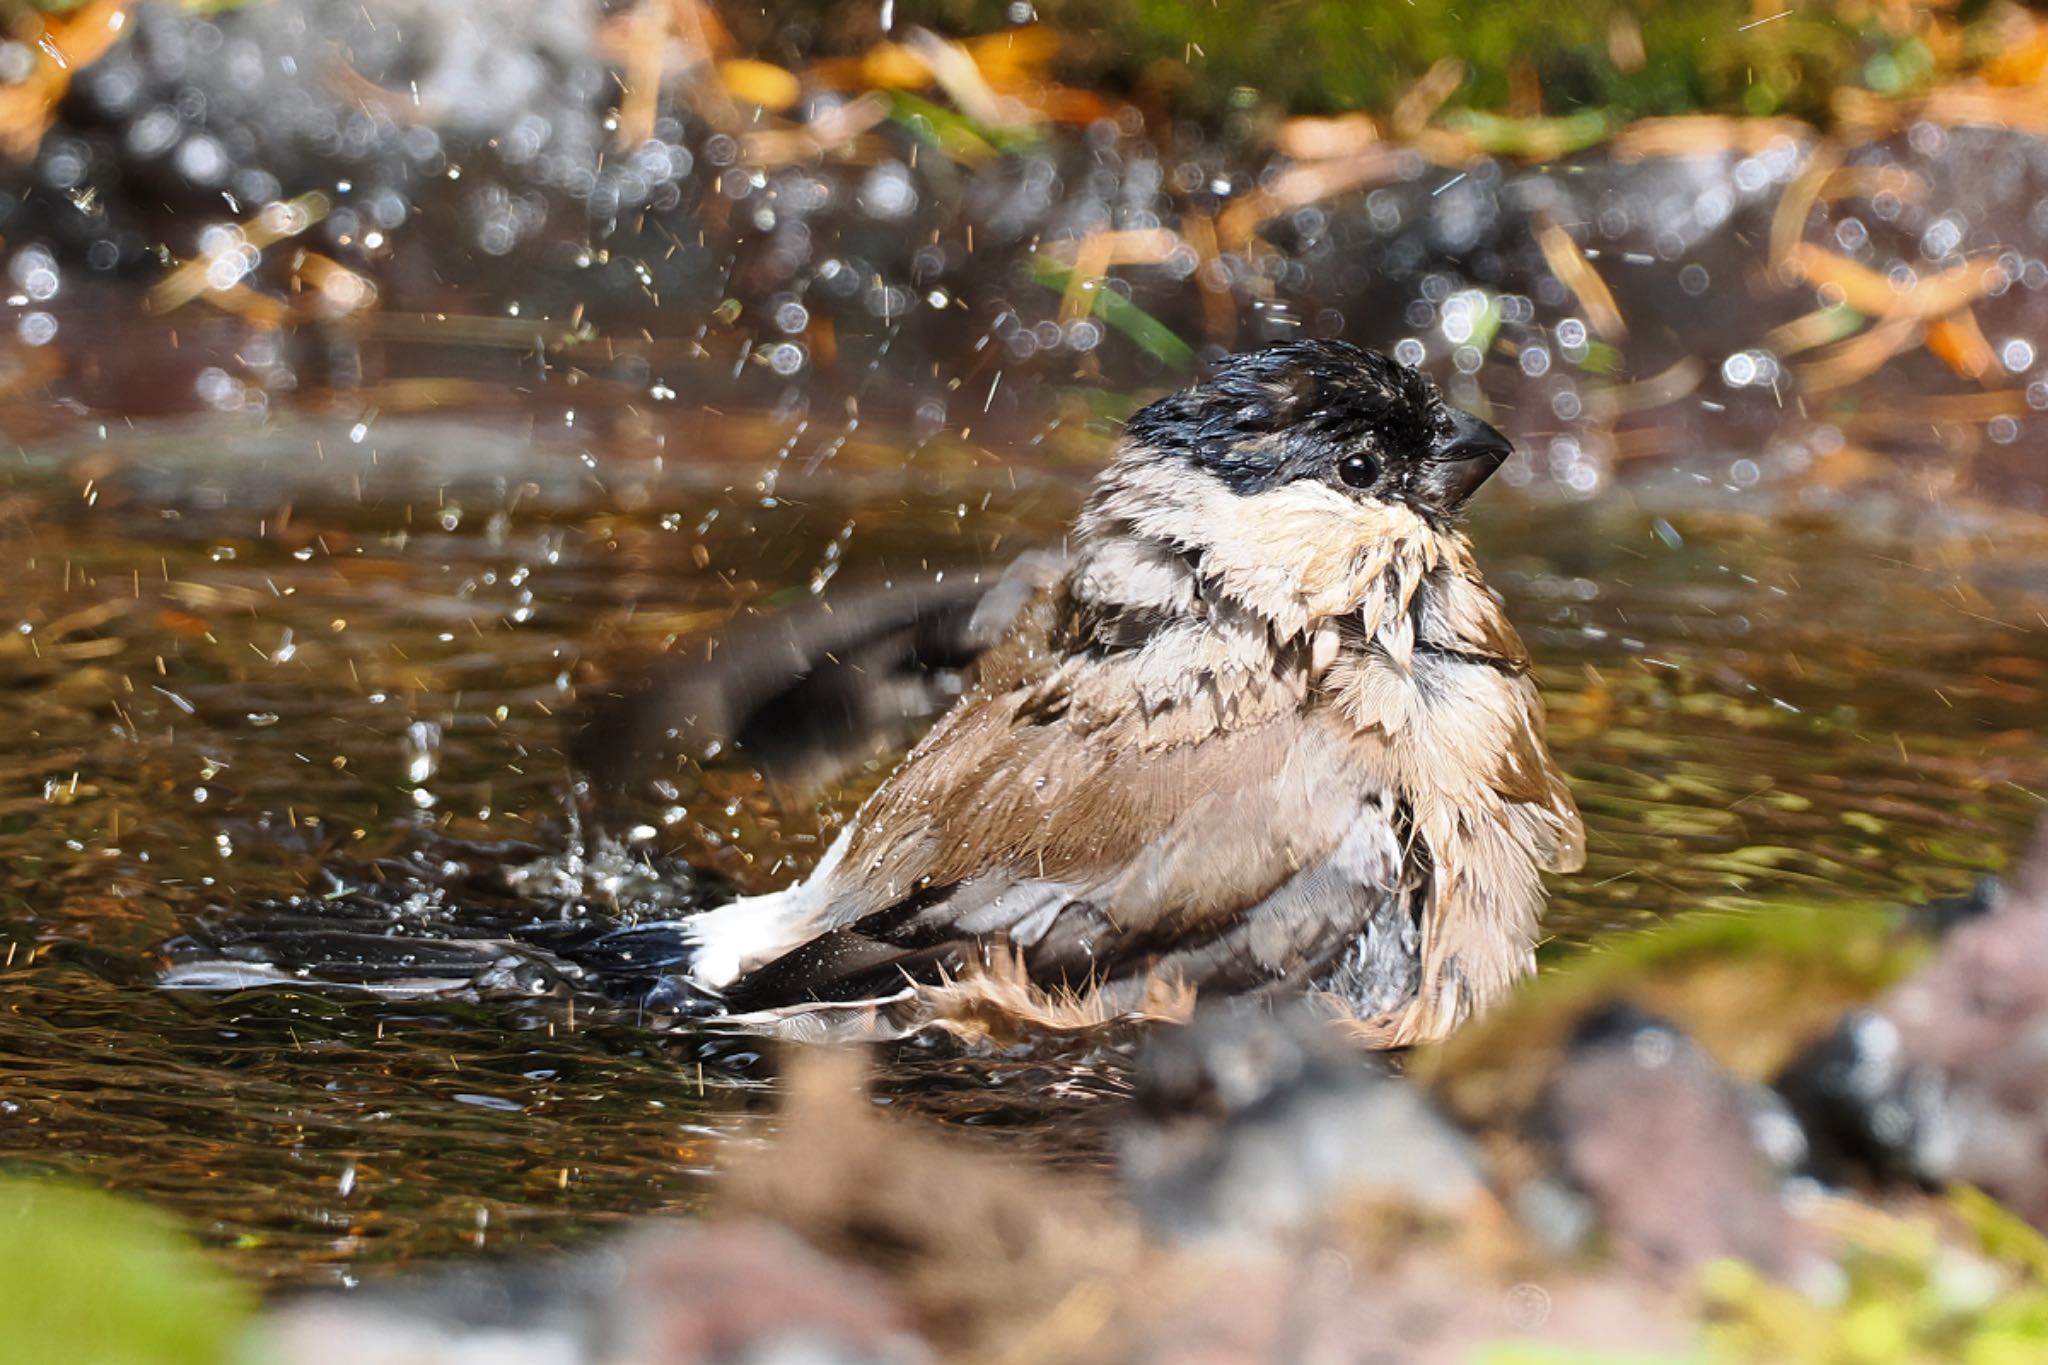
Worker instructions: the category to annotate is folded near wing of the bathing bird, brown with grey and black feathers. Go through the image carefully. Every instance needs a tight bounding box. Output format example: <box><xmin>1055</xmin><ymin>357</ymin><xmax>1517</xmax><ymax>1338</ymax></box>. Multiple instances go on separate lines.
<box><xmin>735</xmin><ymin>692</ymin><xmax>1415</xmax><ymax>1007</ymax></box>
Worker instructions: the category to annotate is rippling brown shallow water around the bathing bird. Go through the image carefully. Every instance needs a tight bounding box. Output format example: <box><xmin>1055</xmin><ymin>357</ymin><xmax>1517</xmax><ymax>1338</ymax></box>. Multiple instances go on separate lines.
<box><xmin>0</xmin><ymin>411</ymin><xmax>2048</xmax><ymax>1281</ymax></box>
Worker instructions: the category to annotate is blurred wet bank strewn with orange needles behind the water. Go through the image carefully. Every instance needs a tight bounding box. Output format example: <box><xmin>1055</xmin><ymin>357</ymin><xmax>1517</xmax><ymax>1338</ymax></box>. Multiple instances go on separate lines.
<box><xmin>0</xmin><ymin>0</ymin><xmax>2048</xmax><ymax>497</ymax></box>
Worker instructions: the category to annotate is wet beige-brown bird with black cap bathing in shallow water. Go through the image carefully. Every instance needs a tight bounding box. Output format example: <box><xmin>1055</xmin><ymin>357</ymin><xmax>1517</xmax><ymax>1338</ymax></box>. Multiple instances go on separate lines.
<box><xmin>666</xmin><ymin>342</ymin><xmax>1583</xmax><ymax>1046</ymax></box>
